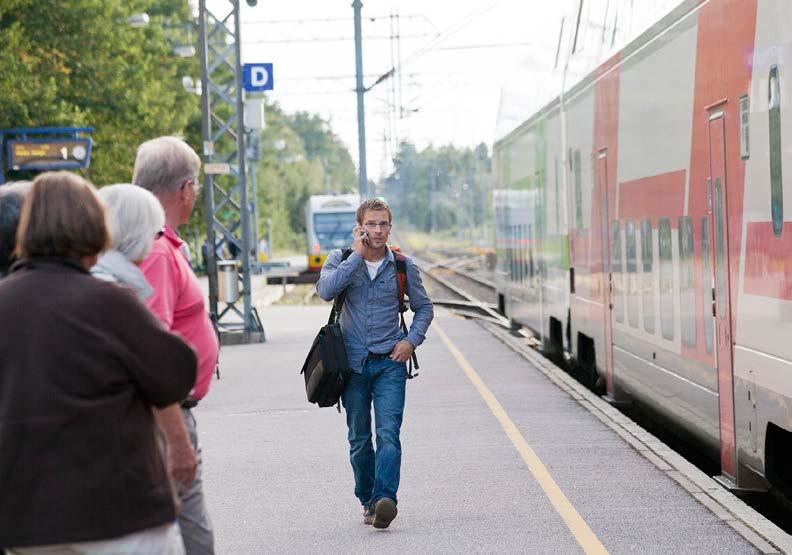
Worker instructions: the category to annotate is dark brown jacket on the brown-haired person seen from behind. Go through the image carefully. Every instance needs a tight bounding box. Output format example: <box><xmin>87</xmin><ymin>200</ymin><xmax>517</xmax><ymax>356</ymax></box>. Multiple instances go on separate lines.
<box><xmin>0</xmin><ymin>259</ymin><xmax>197</xmax><ymax>547</ymax></box>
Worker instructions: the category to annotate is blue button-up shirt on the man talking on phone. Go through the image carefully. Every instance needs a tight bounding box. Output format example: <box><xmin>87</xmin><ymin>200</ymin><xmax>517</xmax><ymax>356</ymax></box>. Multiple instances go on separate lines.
<box><xmin>316</xmin><ymin>249</ymin><xmax>434</xmax><ymax>372</ymax></box>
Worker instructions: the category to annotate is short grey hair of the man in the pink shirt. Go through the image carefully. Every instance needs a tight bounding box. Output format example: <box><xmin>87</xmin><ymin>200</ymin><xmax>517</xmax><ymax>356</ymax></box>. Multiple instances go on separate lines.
<box><xmin>132</xmin><ymin>137</ymin><xmax>201</xmax><ymax>197</ymax></box>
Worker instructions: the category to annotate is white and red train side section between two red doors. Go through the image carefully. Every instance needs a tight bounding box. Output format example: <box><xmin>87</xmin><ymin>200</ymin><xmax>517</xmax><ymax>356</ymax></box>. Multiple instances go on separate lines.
<box><xmin>609</xmin><ymin>6</ymin><xmax>719</xmax><ymax>449</ymax></box>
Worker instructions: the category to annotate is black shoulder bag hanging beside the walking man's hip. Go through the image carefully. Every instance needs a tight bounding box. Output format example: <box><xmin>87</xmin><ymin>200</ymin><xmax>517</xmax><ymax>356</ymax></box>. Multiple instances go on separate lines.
<box><xmin>300</xmin><ymin>249</ymin><xmax>352</xmax><ymax>406</ymax></box>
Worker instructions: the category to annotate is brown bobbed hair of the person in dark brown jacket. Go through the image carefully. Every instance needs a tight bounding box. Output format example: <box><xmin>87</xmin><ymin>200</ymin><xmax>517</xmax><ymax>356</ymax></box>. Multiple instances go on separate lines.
<box><xmin>15</xmin><ymin>171</ymin><xmax>110</xmax><ymax>260</ymax></box>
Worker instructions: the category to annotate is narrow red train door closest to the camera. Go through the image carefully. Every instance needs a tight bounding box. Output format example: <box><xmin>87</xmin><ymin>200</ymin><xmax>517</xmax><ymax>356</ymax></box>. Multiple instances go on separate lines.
<box><xmin>707</xmin><ymin>104</ymin><xmax>737</xmax><ymax>481</ymax></box>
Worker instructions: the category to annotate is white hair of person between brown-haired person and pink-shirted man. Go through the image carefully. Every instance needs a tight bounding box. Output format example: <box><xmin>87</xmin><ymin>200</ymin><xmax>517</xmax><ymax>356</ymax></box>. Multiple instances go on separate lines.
<box><xmin>99</xmin><ymin>183</ymin><xmax>165</xmax><ymax>262</ymax></box>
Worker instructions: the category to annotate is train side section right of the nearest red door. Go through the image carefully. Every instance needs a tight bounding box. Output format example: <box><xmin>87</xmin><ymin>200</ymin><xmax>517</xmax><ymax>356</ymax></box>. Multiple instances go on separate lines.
<box><xmin>733</xmin><ymin>0</ymin><xmax>792</xmax><ymax>489</ymax></box>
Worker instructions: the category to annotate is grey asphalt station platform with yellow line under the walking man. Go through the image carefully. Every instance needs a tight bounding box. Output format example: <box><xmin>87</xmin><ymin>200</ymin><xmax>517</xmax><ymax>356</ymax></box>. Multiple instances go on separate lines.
<box><xmin>195</xmin><ymin>306</ymin><xmax>783</xmax><ymax>554</ymax></box>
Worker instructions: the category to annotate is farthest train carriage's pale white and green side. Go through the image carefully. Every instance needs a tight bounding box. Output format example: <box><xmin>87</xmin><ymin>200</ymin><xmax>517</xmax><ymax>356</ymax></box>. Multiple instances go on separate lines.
<box><xmin>493</xmin><ymin>110</ymin><xmax>569</xmax><ymax>354</ymax></box>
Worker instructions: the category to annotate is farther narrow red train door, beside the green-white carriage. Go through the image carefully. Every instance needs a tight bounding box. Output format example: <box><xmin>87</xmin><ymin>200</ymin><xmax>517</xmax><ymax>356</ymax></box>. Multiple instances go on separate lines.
<box><xmin>596</xmin><ymin>149</ymin><xmax>616</xmax><ymax>399</ymax></box>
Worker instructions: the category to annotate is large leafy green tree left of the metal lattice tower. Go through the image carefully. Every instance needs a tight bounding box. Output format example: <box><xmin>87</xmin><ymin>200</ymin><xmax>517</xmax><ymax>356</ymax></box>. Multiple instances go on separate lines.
<box><xmin>0</xmin><ymin>0</ymin><xmax>200</xmax><ymax>185</ymax></box>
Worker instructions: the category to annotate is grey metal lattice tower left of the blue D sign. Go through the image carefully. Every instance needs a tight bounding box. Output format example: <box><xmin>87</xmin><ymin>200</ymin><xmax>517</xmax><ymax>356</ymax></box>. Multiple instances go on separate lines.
<box><xmin>198</xmin><ymin>0</ymin><xmax>264</xmax><ymax>344</ymax></box>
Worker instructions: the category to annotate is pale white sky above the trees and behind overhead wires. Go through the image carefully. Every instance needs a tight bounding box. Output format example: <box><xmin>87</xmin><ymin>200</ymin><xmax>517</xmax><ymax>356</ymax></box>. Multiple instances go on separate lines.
<box><xmin>208</xmin><ymin>0</ymin><xmax>576</xmax><ymax>180</ymax></box>
